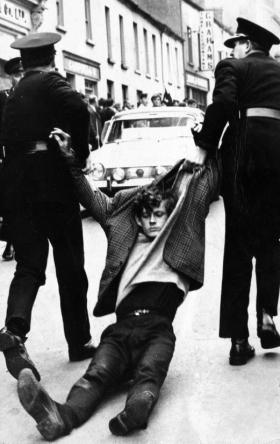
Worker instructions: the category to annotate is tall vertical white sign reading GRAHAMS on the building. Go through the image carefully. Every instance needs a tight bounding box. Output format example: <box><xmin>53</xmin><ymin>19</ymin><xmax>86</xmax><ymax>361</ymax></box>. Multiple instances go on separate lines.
<box><xmin>199</xmin><ymin>11</ymin><xmax>214</xmax><ymax>71</ymax></box>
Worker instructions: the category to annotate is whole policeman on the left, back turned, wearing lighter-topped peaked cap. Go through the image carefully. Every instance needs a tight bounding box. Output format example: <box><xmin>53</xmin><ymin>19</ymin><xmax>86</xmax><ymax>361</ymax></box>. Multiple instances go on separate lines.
<box><xmin>0</xmin><ymin>33</ymin><xmax>95</xmax><ymax>379</ymax></box>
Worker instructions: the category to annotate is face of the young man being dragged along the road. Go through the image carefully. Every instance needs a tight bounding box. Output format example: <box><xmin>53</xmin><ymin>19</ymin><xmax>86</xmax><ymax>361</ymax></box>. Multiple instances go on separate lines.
<box><xmin>136</xmin><ymin>200</ymin><xmax>168</xmax><ymax>240</ymax></box>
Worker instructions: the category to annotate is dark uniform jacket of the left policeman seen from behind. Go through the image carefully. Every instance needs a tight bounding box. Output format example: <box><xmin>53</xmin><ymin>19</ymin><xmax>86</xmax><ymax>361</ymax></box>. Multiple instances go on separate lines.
<box><xmin>0</xmin><ymin>70</ymin><xmax>89</xmax><ymax>211</ymax></box>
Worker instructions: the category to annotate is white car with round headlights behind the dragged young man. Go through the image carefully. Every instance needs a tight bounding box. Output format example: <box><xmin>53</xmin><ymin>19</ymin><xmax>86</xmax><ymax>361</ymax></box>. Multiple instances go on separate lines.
<box><xmin>87</xmin><ymin>106</ymin><xmax>204</xmax><ymax>194</ymax></box>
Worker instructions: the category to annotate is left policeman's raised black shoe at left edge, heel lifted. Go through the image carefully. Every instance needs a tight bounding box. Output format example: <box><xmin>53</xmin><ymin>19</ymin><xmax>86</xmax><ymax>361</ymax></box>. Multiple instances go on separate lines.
<box><xmin>0</xmin><ymin>327</ymin><xmax>40</xmax><ymax>381</ymax></box>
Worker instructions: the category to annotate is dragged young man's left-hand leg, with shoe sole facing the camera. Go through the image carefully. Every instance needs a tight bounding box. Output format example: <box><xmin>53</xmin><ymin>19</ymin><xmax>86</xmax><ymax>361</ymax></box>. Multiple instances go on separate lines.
<box><xmin>18</xmin><ymin>324</ymin><xmax>128</xmax><ymax>440</ymax></box>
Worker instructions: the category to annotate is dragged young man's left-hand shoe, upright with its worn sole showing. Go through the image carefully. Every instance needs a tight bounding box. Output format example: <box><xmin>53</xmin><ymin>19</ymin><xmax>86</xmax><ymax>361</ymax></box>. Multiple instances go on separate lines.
<box><xmin>18</xmin><ymin>369</ymin><xmax>68</xmax><ymax>441</ymax></box>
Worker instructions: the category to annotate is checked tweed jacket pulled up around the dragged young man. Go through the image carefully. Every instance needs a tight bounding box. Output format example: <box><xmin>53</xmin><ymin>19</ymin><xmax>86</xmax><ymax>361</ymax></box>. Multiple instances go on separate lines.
<box><xmin>72</xmin><ymin>158</ymin><xmax>219</xmax><ymax>316</ymax></box>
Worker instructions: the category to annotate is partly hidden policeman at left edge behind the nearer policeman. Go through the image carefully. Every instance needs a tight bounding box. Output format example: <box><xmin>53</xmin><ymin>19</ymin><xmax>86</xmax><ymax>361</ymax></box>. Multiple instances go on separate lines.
<box><xmin>0</xmin><ymin>57</ymin><xmax>23</xmax><ymax>261</ymax></box>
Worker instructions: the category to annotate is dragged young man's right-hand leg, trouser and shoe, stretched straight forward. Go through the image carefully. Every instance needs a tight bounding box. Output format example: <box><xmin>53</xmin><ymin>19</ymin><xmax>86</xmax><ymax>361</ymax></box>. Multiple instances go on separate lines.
<box><xmin>109</xmin><ymin>318</ymin><xmax>176</xmax><ymax>435</ymax></box>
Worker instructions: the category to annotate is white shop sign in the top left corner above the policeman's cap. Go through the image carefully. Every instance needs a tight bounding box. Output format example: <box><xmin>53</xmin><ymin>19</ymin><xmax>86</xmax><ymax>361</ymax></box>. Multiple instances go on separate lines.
<box><xmin>0</xmin><ymin>0</ymin><xmax>31</xmax><ymax>29</ymax></box>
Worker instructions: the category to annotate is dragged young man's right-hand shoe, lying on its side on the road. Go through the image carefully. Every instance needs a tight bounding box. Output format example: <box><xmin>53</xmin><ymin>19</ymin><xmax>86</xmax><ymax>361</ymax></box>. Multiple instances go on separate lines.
<box><xmin>109</xmin><ymin>391</ymin><xmax>155</xmax><ymax>436</ymax></box>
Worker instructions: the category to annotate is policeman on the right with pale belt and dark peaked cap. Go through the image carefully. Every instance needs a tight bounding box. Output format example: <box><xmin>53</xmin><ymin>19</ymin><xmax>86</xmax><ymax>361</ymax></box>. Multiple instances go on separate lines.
<box><xmin>194</xmin><ymin>18</ymin><xmax>280</xmax><ymax>365</ymax></box>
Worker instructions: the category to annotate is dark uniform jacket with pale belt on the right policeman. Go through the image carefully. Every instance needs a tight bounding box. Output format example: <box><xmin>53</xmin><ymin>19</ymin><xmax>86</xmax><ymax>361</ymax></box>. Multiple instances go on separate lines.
<box><xmin>195</xmin><ymin>52</ymin><xmax>280</xmax><ymax>229</ymax></box>
